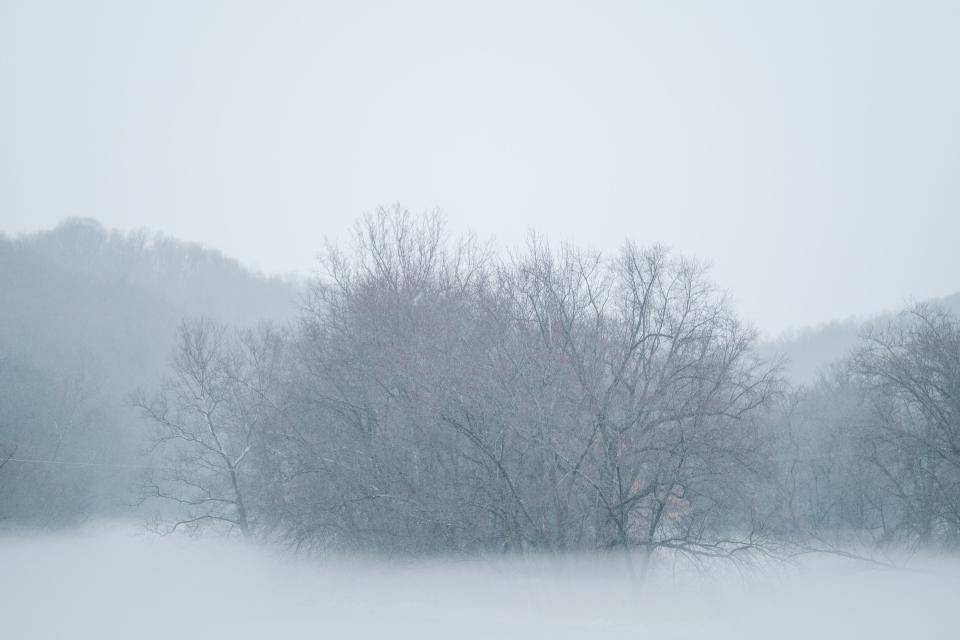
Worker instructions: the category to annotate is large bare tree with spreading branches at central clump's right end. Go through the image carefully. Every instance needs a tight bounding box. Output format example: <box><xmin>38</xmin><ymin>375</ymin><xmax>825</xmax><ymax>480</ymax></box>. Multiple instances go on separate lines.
<box><xmin>502</xmin><ymin>239</ymin><xmax>778</xmax><ymax>568</ymax></box>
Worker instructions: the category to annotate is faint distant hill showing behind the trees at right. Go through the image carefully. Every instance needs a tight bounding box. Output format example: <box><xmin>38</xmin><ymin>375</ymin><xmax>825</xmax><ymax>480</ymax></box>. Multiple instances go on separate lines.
<box><xmin>760</xmin><ymin>293</ymin><xmax>960</xmax><ymax>384</ymax></box>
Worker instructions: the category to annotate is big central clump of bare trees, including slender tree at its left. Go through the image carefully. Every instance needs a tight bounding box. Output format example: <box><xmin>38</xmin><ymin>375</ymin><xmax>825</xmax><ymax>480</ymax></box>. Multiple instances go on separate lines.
<box><xmin>140</xmin><ymin>211</ymin><xmax>778</xmax><ymax>555</ymax></box>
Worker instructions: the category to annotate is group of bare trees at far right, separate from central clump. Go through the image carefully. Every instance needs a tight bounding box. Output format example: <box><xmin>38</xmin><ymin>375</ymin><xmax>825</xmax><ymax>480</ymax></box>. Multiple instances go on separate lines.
<box><xmin>772</xmin><ymin>305</ymin><xmax>960</xmax><ymax>547</ymax></box>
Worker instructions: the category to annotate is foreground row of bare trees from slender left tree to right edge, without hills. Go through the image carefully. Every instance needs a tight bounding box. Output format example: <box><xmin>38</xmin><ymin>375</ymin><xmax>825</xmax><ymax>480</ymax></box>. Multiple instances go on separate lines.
<box><xmin>133</xmin><ymin>208</ymin><xmax>960</xmax><ymax>558</ymax></box>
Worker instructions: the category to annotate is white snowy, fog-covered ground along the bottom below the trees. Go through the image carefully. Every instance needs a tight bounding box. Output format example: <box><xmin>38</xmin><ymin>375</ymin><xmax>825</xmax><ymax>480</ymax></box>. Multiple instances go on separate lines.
<box><xmin>0</xmin><ymin>528</ymin><xmax>960</xmax><ymax>640</ymax></box>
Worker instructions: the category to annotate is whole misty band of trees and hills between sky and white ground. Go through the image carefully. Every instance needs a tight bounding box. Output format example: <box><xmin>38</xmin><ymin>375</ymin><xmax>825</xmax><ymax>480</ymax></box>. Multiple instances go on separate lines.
<box><xmin>0</xmin><ymin>207</ymin><xmax>960</xmax><ymax>558</ymax></box>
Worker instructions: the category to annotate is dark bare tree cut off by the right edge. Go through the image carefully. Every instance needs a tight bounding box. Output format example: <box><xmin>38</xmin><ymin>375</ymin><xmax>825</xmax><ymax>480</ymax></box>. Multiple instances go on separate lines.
<box><xmin>851</xmin><ymin>305</ymin><xmax>960</xmax><ymax>545</ymax></box>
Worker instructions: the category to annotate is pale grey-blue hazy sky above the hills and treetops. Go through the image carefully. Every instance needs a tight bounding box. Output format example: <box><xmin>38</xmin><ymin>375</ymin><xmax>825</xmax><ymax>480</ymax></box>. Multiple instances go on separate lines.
<box><xmin>0</xmin><ymin>0</ymin><xmax>960</xmax><ymax>334</ymax></box>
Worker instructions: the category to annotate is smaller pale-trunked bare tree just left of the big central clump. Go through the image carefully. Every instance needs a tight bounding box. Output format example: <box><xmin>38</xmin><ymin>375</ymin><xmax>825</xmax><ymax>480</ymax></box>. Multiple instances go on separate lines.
<box><xmin>134</xmin><ymin>320</ymin><xmax>283</xmax><ymax>537</ymax></box>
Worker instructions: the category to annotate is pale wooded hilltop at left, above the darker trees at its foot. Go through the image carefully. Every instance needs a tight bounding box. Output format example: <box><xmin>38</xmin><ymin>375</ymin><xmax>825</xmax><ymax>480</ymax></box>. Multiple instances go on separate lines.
<box><xmin>0</xmin><ymin>219</ymin><xmax>299</xmax><ymax>393</ymax></box>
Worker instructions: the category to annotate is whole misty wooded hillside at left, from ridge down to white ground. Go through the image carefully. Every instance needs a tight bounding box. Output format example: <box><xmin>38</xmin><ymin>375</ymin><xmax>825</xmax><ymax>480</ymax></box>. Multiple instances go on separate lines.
<box><xmin>0</xmin><ymin>219</ymin><xmax>299</xmax><ymax>527</ymax></box>
